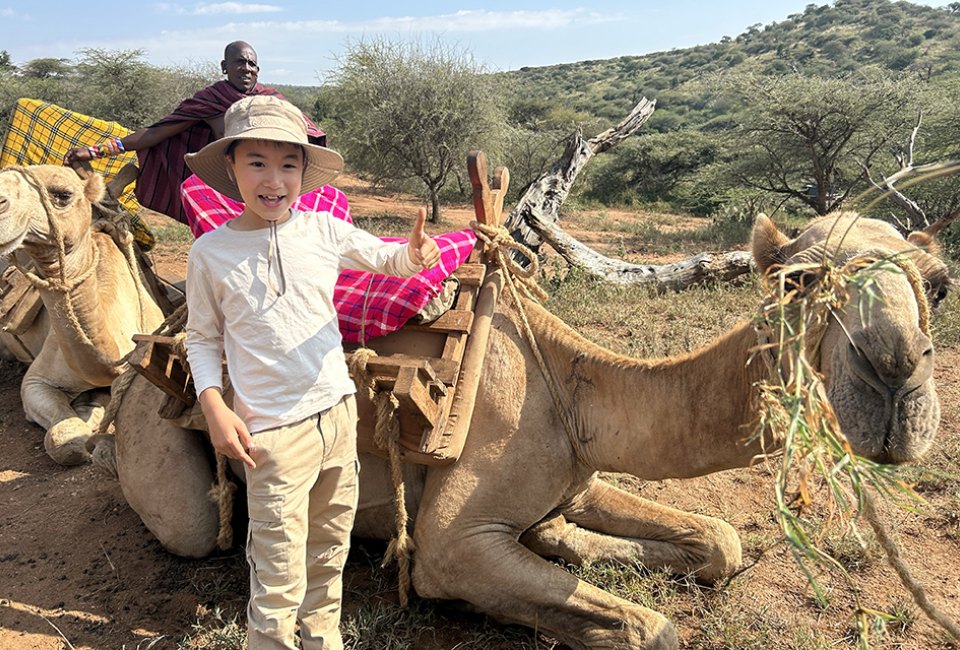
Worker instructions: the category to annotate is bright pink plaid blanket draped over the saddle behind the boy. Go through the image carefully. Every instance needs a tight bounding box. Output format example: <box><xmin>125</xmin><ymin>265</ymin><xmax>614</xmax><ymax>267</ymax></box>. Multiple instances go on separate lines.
<box><xmin>180</xmin><ymin>175</ymin><xmax>477</xmax><ymax>342</ymax></box>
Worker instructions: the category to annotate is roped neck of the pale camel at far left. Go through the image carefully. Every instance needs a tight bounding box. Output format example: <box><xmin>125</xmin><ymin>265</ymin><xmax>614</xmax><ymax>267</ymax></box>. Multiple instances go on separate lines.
<box><xmin>25</xmin><ymin>234</ymin><xmax>120</xmax><ymax>374</ymax></box>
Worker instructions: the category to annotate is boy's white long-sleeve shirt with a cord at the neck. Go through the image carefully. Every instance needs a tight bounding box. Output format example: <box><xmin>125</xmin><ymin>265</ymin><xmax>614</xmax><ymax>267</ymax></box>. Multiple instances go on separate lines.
<box><xmin>186</xmin><ymin>211</ymin><xmax>419</xmax><ymax>433</ymax></box>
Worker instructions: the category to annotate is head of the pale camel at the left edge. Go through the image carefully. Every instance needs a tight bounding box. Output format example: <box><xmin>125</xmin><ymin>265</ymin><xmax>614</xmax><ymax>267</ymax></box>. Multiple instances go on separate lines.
<box><xmin>0</xmin><ymin>165</ymin><xmax>104</xmax><ymax>255</ymax></box>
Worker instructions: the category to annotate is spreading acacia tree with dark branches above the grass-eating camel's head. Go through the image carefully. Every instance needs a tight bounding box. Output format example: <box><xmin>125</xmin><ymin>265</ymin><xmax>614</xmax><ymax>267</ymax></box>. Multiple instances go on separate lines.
<box><xmin>718</xmin><ymin>74</ymin><xmax>916</xmax><ymax>215</ymax></box>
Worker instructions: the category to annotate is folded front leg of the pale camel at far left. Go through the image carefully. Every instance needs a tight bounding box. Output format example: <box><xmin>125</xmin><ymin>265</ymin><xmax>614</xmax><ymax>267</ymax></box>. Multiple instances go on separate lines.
<box><xmin>20</xmin><ymin>357</ymin><xmax>93</xmax><ymax>465</ymax></box>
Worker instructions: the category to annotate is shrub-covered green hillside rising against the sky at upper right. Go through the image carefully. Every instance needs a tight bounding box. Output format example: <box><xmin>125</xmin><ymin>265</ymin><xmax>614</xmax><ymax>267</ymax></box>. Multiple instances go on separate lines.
<box><xmin>497</xmin><ymin>0</ymin><xmax>960</xmax><ymax>131</ymax></box>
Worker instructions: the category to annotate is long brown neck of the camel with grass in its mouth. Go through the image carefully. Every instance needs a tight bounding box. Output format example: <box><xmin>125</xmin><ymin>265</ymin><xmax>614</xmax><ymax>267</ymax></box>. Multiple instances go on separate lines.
<box><xmin>531</xmin><ymin>298</ymin><xmax>764</xmax><ymax>479</ymax></box>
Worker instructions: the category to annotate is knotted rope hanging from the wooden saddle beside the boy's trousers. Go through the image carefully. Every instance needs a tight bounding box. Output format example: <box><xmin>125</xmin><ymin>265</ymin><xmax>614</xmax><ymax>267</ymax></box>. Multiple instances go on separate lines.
<box><xmin>349</xmin><ymin>348</ymin><xmax>414</xmax><ymax>607</ymax></box>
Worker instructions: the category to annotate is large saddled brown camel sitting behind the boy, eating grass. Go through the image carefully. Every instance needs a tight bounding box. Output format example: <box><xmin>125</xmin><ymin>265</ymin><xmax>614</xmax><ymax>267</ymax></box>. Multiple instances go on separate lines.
<box><xmin>105</xmin><ymin>214</ymin><xmax>949</xmax><ymax>650</ymax></box>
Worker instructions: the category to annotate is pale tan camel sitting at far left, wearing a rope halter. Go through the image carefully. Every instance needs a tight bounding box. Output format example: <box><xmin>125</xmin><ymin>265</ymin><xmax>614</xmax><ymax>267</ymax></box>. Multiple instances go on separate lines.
<box><xmin>0</xmin><ymin>165</ymin><xmax>163</xmax><ymax>465</ymax></box>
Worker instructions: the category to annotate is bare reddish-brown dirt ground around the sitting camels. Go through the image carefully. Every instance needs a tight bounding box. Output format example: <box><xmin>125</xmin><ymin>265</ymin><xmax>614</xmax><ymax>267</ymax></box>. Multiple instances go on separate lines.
<box><xmin>0</xmin><ymin>178</ymin><xmax>960</xmax><ymax>650</ymax></box>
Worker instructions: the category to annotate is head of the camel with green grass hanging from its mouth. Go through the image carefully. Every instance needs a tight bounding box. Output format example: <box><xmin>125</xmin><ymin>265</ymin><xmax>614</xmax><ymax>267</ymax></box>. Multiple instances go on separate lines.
<box><xmin>752</xmin><ymin>213</ymin><xmax>949</xmax><ymax>463</ymax></box>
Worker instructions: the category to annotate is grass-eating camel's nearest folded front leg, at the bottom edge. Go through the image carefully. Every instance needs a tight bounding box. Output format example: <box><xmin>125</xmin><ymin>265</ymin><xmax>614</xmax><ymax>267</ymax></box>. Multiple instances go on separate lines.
<box><xmin>413</xmin><ymin>529</ymin><xmax>678</xmax><ymax>650</ymax></box>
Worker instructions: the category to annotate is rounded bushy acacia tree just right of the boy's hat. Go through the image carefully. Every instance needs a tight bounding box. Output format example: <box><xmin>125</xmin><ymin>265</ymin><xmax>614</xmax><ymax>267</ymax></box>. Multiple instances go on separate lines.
<box><xmin>333</xmin><ymin>40</ymin><xmax>504</xmax><ymax>223</ymax></box>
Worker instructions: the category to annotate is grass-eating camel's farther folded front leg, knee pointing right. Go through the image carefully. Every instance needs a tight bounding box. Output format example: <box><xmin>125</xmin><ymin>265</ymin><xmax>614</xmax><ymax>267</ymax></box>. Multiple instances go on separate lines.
<box><xmin>520</xmin><ymin>478</ymin><xmax>742</xmax><ymax>582</ymax></box>
